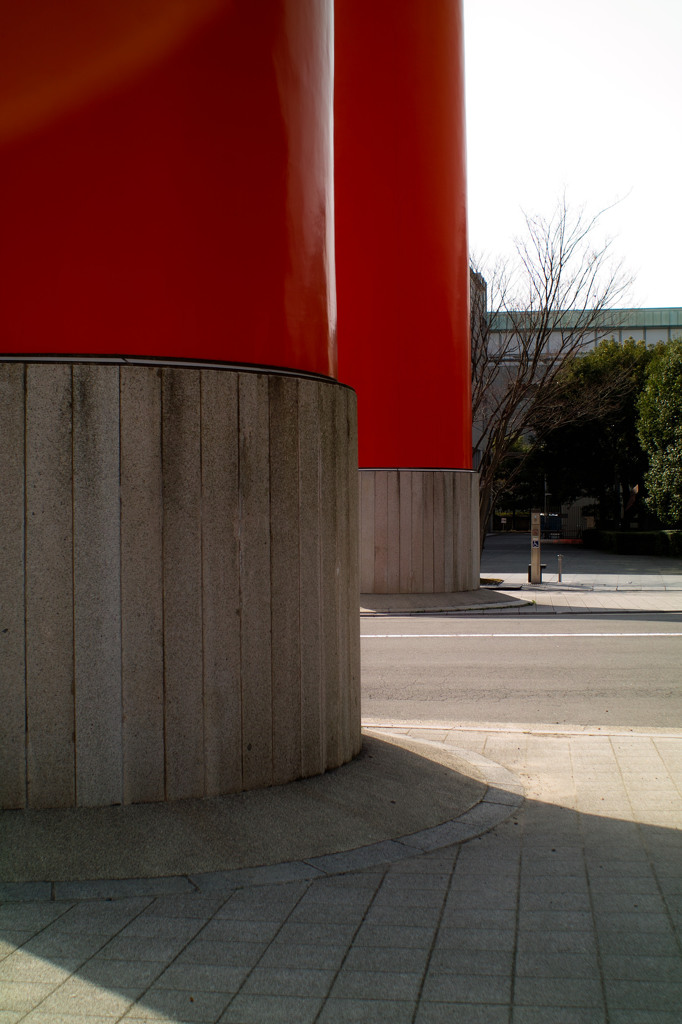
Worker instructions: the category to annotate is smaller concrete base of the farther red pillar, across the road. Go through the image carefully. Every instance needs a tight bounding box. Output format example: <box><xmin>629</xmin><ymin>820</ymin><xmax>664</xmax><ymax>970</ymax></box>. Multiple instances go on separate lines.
<box><xmin>359</xmin><ymin>469</ymin><xmax>480</xmax><ymax>594</ymax></box>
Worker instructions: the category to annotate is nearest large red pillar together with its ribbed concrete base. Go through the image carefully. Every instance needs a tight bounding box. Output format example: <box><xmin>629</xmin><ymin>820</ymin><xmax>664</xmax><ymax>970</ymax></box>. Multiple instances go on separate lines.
<box><xmin>0</xmin><ymin>0</ymin><xmax>360</xmax><ymax>808</ymax></box>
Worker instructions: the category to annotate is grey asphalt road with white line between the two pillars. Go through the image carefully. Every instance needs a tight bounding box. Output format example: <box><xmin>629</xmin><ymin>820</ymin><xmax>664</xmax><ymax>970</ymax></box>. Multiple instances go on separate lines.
<box><xmin>361</xmin><ymin>614</ymin><xmax>682</xmax><ymax>728</ymax></box>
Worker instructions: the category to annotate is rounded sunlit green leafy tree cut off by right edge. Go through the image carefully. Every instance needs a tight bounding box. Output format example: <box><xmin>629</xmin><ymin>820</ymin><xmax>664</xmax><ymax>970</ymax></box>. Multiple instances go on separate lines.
<box><xmin>639</xmin><ymin>338</ymin><xmax>682</xmax><ymax>527</ymax></box>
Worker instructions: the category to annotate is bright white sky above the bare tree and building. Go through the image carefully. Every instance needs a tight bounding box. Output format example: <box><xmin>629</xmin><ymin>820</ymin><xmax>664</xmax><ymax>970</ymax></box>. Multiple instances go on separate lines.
<box><xmin>464</xmin><ymin>0</ymin><xmax>682</xmax><ymax>306</ymax></box>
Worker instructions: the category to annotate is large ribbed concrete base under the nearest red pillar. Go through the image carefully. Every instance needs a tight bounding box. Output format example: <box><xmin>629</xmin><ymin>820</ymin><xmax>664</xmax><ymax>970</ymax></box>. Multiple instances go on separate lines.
<box><xmin>0</xmin><ymin>361</ymin><xmax>360</xmax><ymax>808</ymax></box>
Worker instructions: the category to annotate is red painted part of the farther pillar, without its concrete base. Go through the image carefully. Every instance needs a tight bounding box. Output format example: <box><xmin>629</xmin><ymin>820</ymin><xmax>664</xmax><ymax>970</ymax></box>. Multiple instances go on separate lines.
<box><xmin>335</xmin><ymin>0</ymin><xmax>471</xmax><ymax>469</ymax></box>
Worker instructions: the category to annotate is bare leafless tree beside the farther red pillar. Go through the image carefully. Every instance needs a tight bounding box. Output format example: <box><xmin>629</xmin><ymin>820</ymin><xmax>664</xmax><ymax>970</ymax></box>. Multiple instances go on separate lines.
<box><xmin>471</xmin><ymin>196</ymin><xmax>632</xmax><ymax>544</ymax></box>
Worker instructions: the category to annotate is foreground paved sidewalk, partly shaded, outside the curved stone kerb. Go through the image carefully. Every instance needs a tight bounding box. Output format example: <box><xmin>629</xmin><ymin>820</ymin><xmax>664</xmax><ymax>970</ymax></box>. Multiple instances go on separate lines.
<box><xmin>0</xmin><ymin>729</ymin><xmax>682</xmax><ymax>1024</ymax></box>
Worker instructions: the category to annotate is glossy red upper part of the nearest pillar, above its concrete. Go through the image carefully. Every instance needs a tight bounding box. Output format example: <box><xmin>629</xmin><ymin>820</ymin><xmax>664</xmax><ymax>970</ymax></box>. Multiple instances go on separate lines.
<box><xmin>0</xmin><ymin>0</ymin><xmax>336</xmax><ymax>376</ymax></box>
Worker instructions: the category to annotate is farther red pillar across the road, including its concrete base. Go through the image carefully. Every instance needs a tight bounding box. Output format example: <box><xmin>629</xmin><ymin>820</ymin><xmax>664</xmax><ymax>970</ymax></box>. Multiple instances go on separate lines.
<box><xmin>335</xmin><ymin>0</ymin><xmax>479</xmax><ymax>593</ymax></box>
